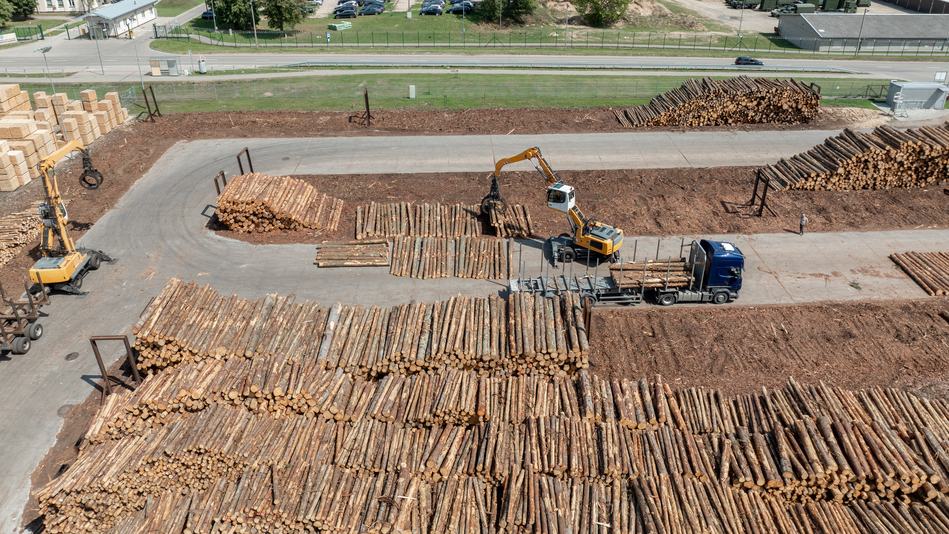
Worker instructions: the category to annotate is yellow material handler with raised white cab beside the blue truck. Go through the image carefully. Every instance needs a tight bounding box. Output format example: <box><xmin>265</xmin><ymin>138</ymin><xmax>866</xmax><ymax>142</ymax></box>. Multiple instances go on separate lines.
<box><xmin>481</xmin><ymin>147</ymin><xmax>623</xmax><ymax>262</ymax></box>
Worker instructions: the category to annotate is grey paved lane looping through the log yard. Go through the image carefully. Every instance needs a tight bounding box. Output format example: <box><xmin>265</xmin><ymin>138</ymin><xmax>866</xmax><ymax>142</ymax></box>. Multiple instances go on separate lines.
<box><xmin>0</xmin><ymin>132</ymin><xmax>949</xmax><ymax>532</ymax></box>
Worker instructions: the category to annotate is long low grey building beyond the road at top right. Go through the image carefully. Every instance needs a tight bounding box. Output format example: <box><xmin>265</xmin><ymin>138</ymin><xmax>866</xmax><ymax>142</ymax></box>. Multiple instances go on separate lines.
<box><xmin>778</xmin><ymin>13</ymin><xmax>949</xmax><ymax>51</ymax></box>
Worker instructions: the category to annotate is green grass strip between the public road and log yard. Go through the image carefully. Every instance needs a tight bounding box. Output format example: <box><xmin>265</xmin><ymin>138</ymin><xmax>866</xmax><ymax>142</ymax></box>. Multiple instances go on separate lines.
<box><xmin>16</xmin><ymin>74</ymin><xmax>887</xmax><ymax>113</ymax></box>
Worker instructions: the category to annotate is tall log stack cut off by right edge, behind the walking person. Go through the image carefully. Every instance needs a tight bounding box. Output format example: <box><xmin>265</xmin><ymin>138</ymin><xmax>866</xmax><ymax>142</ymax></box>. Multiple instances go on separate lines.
<box><xmin>760</xmin><ymin>123</ymin><xmax>949</xmax><ymax>191</ymax></box>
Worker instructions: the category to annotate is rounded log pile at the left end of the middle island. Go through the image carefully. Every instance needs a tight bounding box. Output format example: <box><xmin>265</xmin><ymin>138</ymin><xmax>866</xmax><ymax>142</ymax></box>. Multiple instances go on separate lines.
<box><xmin>217</xmin><ymin>173</ymin><xmax>343</xmax><ymax>233</ymax></box>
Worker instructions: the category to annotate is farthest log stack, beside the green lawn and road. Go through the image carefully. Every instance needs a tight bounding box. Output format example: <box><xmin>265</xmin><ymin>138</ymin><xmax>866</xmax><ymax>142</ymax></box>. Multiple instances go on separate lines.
<box><xmin>616</xmin><ymin>76</ymin><xmax>820</xmax><ymax>128</ymax></box>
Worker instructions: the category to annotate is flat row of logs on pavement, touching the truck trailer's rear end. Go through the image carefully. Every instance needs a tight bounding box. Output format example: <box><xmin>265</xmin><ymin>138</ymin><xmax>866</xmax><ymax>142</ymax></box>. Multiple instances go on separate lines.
<box><xmin>389</xmin><ymin>237</ymin><xmax>514</xmax><ymax>280</ymax></box>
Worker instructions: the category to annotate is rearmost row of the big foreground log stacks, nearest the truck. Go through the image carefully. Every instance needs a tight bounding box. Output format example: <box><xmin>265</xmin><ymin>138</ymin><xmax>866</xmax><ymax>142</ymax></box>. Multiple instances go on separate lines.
<box><xmin>133</xmin><ymin>279</ymin><xmax>589</xmax><ymax>376</ymax></box>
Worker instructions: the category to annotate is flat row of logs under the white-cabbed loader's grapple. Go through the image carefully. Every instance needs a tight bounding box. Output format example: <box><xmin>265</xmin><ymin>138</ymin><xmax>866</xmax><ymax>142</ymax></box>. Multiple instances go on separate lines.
<box><xmin>356</xmin><ymin>202</ymin><xmax>533</xmax><ymax>240</ymax></box>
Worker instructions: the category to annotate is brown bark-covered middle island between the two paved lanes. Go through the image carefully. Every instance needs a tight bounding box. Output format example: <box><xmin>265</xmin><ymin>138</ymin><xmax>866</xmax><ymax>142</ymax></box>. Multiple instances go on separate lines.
<box><xmin>213</xmin><ymin>167</ymin><xmax>949</xmax><ymax>243</ymax></box>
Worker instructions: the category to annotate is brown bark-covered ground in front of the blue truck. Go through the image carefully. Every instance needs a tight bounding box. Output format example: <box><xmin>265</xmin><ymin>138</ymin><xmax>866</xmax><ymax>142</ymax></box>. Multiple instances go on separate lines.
<box><xmin>591</xmin><ymin>299</ymin><xmax>949</xmax><ymax>398</ymax></box>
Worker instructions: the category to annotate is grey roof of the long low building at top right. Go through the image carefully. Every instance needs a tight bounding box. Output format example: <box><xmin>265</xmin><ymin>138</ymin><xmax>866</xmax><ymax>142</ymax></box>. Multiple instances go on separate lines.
<box><xmin>796</xmin><ymin>13</ymin><xmax>949</xmax><ymax>39</ymax></box>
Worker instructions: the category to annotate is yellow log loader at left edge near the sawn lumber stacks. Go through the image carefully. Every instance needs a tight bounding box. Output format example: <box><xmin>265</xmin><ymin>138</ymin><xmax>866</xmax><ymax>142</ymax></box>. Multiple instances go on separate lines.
<box><xmin>30</xmin><ymin>141</ymin><xmax>114</xmax><ymax>295</ymax></box>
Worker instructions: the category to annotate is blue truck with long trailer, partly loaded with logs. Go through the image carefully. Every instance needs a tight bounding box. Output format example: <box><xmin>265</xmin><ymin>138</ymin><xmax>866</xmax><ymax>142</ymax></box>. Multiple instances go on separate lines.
<box><xmin>509</xmin><ymin>239</ymin><xmax>745</xmax><ymax>306</ymax></box>
